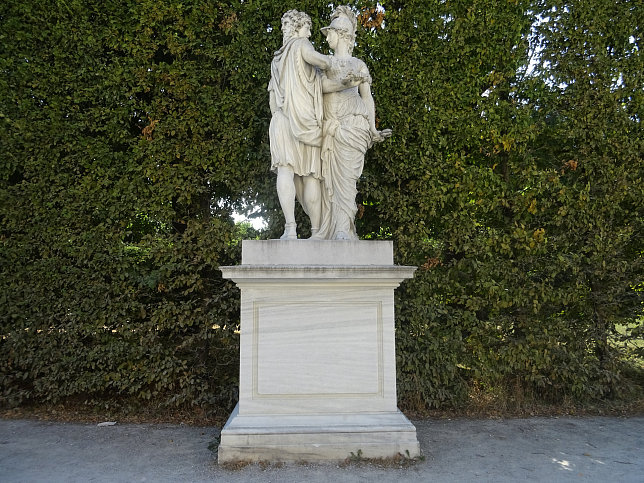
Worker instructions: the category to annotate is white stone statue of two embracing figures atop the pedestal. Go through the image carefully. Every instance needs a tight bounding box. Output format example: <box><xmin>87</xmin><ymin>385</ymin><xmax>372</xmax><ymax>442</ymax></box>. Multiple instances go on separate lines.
<box><xmin>268</xmin><ymin>6</ymin><xmax>391</xmax><ymax>240</ymax></box>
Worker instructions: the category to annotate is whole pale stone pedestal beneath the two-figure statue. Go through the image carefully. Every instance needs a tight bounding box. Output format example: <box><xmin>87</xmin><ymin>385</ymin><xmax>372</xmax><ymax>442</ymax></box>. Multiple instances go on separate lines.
<box><xmin>218</xmin><ymin>240</ymin><xmax>420</xmax><ymax>463</ymax></box>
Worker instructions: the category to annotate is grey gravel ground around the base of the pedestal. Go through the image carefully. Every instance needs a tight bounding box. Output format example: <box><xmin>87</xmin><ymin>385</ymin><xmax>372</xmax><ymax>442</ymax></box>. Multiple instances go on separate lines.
<box><xmin>0</xmin><ymin>417</ymin><xmax>644</xmax><ymax>483</ymax></box>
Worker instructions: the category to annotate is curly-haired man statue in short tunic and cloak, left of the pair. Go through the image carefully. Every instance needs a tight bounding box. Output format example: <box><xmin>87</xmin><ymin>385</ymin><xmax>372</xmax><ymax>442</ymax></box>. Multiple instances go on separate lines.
<box><xmin>268</xmin><ymin>10</ymin><xmax>331</xmax><ymax>240</ymax></box>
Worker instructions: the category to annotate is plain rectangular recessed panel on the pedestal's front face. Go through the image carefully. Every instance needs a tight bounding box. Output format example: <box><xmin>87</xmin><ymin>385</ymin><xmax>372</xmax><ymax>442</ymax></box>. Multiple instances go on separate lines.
<box><xmin>253</xmin><ymin>301</ymin><xmax>383</xmax><ymax>399</ymax></box>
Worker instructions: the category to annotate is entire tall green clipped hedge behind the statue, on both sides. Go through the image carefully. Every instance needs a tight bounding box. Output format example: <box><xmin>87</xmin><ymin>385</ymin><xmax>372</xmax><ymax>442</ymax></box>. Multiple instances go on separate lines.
<box><xmin>0</xmin><ymin>0</ymin><xmax>644</xmax><ymax>416</ymax></box>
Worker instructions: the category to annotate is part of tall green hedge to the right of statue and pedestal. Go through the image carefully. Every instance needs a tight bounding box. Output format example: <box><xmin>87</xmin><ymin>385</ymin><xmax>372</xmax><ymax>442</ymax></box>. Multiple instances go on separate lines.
<box><xmin>359</xmin><ymin>0</ymin><xmax>644</xmax><ymax>407</ymax></box>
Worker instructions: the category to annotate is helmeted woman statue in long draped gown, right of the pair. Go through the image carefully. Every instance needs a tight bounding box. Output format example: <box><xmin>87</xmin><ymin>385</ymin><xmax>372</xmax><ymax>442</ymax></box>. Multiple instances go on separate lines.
<box><xmin>315</xmin><ymin>7</ymin><xmax>391</xmax><ymax>240</ymax></box>
